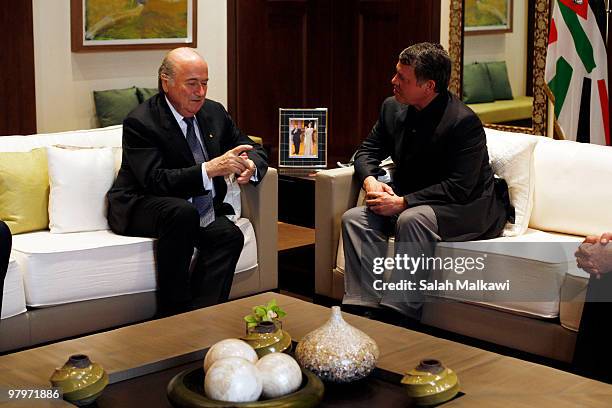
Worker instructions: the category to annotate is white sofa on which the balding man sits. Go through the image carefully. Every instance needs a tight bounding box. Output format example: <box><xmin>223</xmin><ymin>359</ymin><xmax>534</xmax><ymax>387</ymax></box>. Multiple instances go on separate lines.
<box><xmin>0</xmin><ymin>125</ymin><xmax>278</xmax><ymax>350</ymax></box>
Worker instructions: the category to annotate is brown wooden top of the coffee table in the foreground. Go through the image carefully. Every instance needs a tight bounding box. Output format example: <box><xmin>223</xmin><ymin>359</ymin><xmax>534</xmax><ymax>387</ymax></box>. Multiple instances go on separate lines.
<box><xmin>0</xmin><ymin>293</ymin><xmax>612</xmax><ymax>407</ymax></box>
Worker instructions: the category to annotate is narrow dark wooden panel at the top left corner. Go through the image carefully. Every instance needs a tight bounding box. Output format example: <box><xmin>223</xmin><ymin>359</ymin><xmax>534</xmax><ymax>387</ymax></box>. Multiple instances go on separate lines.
<box><xmin>0</xmin><ymin>1</ymin><xmax>36</xmax><ymax>136</ymax></box>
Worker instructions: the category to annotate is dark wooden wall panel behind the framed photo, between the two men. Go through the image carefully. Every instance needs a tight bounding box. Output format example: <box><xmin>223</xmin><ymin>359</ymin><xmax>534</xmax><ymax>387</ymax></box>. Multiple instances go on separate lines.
<box><xmin>228</xmin><ymin>0</ymin><xmax>440</xmax><ymax>167</ymax></box>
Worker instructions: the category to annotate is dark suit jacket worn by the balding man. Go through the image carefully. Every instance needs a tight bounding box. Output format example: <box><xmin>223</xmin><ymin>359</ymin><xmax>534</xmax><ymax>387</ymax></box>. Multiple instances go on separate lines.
<box><xmin>107</xmin><ymin>94</ymin><xmax>268</xmax><ymax>233</ymax></box>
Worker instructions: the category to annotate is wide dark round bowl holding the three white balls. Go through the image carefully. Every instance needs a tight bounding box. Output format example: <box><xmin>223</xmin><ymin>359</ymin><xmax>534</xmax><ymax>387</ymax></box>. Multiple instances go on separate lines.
<box><xmin>167</xmin><ymin>367</ymin><xmax>324</xmax><ymax>408</ymax></box>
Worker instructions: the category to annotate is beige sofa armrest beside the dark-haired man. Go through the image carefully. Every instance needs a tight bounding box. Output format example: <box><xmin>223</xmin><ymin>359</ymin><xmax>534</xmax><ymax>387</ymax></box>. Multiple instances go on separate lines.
<box><xmin>315</xmin><ymin>167</ymin><xmax>360</xmax><ymax>297</ymax></box>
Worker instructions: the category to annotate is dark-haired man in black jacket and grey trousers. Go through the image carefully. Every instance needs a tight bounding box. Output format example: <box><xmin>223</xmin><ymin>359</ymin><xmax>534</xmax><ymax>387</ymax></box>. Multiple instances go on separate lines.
<box><xmin>342</xmin><ymin>43</ymin><xmax>506</xmax><ymax>318</ymax></box>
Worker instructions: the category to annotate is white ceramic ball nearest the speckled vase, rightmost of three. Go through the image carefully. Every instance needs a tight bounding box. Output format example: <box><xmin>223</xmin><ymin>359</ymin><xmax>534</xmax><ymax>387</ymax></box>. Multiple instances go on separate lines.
<box><xmin>256</xmin><ymin>353</ymin><xmax>302</xmax><ymax>398</ymax></box>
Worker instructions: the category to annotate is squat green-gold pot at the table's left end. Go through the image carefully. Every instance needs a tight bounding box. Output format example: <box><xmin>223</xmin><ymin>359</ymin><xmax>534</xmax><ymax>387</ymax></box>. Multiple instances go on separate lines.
<box><xmin>50</xmin><ymin>354</ymin><xmax>108</xmax><ymax>406</ymax></box>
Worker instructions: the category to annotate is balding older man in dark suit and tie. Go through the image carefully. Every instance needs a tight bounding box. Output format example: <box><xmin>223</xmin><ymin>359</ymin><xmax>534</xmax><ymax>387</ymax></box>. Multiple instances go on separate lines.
<box><xmin>108</xmin><ymin>48</ymin><xmax>267</xmax><ymax>314</ymax></box>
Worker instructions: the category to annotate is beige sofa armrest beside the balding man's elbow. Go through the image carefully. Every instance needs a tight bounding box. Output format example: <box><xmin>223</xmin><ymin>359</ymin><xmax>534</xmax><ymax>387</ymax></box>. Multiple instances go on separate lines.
<box><xmin>240</xmin><ymin>167</ymin><xmax>278</xmax><ymax>291</ymax></box>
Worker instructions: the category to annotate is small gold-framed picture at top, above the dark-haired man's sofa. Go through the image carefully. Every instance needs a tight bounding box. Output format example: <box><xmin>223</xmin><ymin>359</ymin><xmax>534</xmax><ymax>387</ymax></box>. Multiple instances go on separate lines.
<box><xmin>464</xmin><ymin>0</ymin><xmax>513</xmax><ymax>35</ymax></box>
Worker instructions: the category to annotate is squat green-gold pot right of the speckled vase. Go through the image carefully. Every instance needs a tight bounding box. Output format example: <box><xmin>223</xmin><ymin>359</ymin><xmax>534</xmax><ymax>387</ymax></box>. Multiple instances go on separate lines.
<box><xmin>402</xmin><ymin>360</ymin><xmax>459</xmax><ymax>405</ymax></box>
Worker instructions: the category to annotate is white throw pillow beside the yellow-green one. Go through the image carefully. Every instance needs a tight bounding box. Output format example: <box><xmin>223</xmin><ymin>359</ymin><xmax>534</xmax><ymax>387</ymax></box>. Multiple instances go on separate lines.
<box><xmin>47</xmin><ymin>146</ymin><xmax>115</xmax><ymax>233</ymax></box>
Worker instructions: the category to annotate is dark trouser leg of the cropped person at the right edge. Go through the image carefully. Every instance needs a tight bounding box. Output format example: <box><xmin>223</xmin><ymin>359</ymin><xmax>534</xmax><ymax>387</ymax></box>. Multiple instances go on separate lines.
<box><xmin>574</xmin><ymin>273</ymin><xmax>612</xmax><ymax>383</ymax></box>
